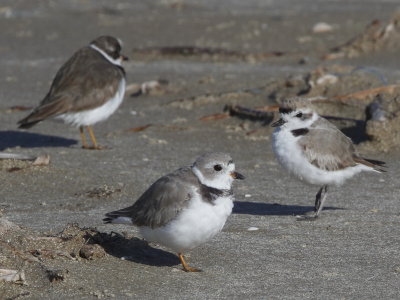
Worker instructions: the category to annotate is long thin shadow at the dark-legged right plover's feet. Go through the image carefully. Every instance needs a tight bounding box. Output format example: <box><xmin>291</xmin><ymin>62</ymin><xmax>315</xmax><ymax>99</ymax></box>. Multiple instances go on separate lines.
<box><xmin>232</xmin><ymin>201</ymin><xmax>344</xmax><ymax>216</ymax></box>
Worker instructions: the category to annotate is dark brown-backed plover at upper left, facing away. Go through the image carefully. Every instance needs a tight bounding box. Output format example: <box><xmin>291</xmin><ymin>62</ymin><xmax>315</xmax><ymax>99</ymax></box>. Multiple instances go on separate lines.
<box><xmin>18</xmin><ymin>36</ymin><xmax>127</xmax><ymax>149</ymax></box>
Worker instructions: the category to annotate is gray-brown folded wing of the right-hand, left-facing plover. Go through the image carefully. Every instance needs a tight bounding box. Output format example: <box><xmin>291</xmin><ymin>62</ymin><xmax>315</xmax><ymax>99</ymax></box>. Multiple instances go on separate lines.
<box><xmin>297</xmin><ymin>128</ymin><xmax>357</xmax><ymax>171</ymax></box>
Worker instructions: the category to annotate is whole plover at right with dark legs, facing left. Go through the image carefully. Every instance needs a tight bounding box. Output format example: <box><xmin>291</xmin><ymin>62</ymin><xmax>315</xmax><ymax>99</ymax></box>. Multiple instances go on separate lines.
<box><xmin>272</xmin><ymin>98</ymin><xmax>384</xmax><ymax>219</ymax></box>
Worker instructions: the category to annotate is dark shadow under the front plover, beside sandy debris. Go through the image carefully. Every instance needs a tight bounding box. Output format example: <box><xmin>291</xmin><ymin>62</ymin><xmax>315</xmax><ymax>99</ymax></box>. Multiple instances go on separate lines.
<box><xmin>89</xmin><ymin>232</ymin><xmax>180</xmax><ymax>267</ymax></box>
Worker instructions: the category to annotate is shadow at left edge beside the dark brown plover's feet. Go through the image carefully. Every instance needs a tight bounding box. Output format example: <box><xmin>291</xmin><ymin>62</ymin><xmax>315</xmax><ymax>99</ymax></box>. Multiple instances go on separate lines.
<box><xmin>0</xmin><ymin>130</ymin><xmax>77</xmax><ymax>151</ymax></box>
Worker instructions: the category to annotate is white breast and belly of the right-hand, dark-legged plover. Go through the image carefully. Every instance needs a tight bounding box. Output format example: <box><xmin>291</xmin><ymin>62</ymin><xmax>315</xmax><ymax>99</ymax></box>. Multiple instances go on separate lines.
<box><xmin>272</xmin><ymin>128</ymin><xmax>373</xmax><ymax>185</ymax></box>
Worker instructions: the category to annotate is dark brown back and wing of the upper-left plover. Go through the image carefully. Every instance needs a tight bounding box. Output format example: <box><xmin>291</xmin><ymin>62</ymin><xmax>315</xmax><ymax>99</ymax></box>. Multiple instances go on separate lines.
<box><xmin>18</xmin><ymin>47</ymin><xmax>125</xmax><ymax>128</ymax></box>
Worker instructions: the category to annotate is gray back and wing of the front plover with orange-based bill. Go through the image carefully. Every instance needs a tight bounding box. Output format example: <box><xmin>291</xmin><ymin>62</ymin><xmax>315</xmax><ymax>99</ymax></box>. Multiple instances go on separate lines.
<box><xmin>103</xmin><ymin>168</ymin><xmax>196</xmax><ymax>228</ymax></box>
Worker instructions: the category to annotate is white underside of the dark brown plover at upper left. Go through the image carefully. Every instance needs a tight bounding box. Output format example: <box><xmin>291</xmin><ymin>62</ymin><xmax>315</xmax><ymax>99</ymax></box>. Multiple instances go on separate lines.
<box><xmin>56</xmin><ymin>78</ymin><xmax>125</xmax><ymax>126</ymax></box>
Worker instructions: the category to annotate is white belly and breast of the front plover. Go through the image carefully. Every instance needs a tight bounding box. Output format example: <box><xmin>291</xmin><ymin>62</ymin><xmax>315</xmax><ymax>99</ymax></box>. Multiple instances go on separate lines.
<box><xmin>140</xmin><ymin>196</ymin><xmax>233</xmax><ymax>252</ymax></box>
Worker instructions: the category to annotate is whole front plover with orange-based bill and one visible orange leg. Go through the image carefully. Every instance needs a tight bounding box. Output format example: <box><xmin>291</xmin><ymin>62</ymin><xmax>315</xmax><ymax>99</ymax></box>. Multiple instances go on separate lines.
<box><xmin>104</xmin><ymin>152</ymin><xmax>244</xmax><ymax>272</ymax></box>
